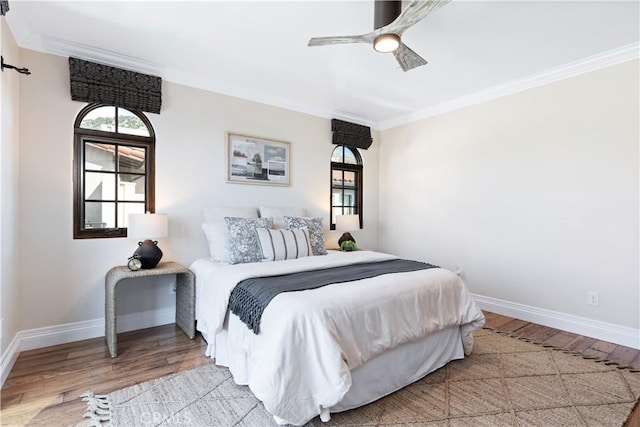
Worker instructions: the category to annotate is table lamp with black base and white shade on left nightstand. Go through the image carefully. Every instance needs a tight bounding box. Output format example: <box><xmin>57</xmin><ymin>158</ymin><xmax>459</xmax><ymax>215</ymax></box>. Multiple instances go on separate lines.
<box><xmin>128</xmin><ymin>213</ymin><xmax>169</xmax><ymax>268</ymax></box>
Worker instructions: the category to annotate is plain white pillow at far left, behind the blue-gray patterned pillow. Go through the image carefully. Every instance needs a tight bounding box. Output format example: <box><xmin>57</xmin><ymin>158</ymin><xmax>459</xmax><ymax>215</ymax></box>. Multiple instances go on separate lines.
<box><xmin>202</xmin><ymin>208</ymin><xmax>258</xmax><ymax>262</ymax></box>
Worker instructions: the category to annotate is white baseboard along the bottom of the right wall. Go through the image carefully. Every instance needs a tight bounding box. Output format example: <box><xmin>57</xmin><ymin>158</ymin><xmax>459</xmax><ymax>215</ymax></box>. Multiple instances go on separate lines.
<box><xmin>473</xmin><ymin>294</ymin><xmax>640</xmax><ymax>350</ymax></box>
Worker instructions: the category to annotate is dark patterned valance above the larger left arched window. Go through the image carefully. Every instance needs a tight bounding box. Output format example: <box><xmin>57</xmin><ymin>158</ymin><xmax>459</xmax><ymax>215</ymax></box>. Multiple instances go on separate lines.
<box><xmin>69</xmin><ymin>58</ymin><xmax>162</xmax><ymax>114</ymax></box>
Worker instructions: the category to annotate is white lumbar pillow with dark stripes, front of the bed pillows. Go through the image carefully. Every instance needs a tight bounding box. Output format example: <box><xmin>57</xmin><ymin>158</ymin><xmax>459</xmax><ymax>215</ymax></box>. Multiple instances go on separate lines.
<box><xmin>256</xmin><ymin>228</ymin><xmax>313</xmax><ymax>261</ymax></box>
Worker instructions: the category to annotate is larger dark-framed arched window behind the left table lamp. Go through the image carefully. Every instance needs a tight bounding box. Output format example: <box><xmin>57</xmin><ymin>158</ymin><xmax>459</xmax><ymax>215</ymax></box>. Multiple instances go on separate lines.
<box><xmin>73</xmin><ymin>104</ymin><xmax>155</xmax><ymax>239</ymax></box>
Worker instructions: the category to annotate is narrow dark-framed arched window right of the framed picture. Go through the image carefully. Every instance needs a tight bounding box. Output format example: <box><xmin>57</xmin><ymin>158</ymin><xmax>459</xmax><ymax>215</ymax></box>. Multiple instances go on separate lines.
<box><xmin>330</xmin><ymin>145</ymin><xmax>362</xmax><ymax>230</ymax></box>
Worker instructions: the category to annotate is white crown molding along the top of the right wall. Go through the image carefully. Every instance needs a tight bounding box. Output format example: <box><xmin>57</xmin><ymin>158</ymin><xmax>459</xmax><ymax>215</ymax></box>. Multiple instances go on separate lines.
<box><xmin>377</xmin><ymin>42</ymin><xmax>640</xmax><ymax>130</ymax></box>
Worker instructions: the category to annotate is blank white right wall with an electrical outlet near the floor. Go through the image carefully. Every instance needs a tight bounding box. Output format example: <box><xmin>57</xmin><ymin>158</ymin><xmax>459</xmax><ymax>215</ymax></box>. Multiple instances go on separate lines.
<box><xmin>379</xmin><ymin>60</ymin><xmax>640</xmax><ymax>331</ymax></box>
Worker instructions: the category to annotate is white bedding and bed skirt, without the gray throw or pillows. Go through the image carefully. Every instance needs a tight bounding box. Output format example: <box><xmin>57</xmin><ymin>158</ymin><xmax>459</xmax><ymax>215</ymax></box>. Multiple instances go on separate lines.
<box><xmin>190</xmin><ymin>207</ymin><xmax>484</xmax><ymax>425</ymax></box>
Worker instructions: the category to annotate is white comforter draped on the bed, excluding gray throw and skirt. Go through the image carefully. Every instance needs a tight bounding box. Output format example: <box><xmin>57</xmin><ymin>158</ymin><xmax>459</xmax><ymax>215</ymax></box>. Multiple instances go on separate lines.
<box><xmin>192</xmin><ymin>251</ymin><xmax>484</xmax><ymax>425</ymax></box>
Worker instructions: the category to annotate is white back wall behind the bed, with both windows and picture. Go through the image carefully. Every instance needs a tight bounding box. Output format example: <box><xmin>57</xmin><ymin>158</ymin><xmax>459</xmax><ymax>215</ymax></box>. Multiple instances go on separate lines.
<box><xmin>18</xmin><ymin>50</ymin><xmax>378</xmax><ymax>330</ymax></box>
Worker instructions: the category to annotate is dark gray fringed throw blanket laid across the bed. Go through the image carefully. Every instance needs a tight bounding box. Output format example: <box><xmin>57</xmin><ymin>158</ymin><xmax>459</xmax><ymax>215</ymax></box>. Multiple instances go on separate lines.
<box><xmin>229</xmin><ymin>259</ymin><xmax>437</xmax><ymax>334</ymax></box>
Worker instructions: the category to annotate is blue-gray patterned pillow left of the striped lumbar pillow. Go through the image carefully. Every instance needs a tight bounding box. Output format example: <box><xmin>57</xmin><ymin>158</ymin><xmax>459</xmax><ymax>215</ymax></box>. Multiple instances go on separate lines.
<box><xmin>224</xmin><ymin>217</ymin><xmax>273</xmax><ymax>264</ymax></box>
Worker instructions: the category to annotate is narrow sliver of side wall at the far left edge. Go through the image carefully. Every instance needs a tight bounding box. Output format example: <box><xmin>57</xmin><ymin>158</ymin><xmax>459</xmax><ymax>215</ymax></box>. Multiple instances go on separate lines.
<box><xmin>0</xmin><ymin>17</ymin><xmax>20</xmax><ymax>362</ymax></box>
